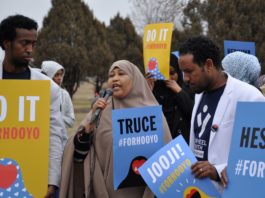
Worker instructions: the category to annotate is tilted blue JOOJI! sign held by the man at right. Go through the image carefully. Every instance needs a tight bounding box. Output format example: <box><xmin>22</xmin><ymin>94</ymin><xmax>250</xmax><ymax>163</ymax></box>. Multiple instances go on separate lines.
<box><xmin>139</xmin><ymin>135</ymin><xmax>220</xmax><ymax>198</ymax></box>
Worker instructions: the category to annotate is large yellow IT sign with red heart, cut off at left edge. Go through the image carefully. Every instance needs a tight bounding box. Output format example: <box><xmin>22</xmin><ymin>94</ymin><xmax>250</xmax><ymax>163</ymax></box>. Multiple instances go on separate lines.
<box><xmin>0</xmin><ymin>80</ymin><xmax>50</xmax><ymax>197</ymax></box>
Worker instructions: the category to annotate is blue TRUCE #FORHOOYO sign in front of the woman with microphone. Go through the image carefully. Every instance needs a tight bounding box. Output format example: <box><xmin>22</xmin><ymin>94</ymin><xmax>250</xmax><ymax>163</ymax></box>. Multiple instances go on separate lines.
<box><xmin>112</xmin><ymin>106</ymin><xmax>164</xmax><ymax>190</ymax></box>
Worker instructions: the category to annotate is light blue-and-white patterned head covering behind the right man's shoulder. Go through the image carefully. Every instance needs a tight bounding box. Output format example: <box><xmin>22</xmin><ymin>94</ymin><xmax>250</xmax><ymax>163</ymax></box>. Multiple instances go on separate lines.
<box><xmin>222</xmin><ymin>51</ymin><xmax>261</xmax><ymax>84</ymax></box>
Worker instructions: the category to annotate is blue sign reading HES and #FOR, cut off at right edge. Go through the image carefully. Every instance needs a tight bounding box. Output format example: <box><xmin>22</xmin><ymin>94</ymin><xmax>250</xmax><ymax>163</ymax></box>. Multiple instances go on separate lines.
<box><xmin>223</xmin><ymin>102</ymin><xmax>265</xmax><ymax>198</ymax></box>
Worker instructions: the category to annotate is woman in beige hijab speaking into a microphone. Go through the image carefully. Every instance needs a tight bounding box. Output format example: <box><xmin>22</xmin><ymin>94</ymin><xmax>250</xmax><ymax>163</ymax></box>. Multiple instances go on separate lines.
<box><xmin>60</xmin><ymin>60</ymin><xmax>171</xmax><ymax>198</ymax></box>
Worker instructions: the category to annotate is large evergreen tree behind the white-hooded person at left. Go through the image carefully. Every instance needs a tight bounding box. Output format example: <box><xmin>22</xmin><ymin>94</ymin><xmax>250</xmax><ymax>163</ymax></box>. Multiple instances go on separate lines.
<box><xmin>35</xmin><ymin>0</ymin><xmax>113</xmax><ymax>96</ymax></box>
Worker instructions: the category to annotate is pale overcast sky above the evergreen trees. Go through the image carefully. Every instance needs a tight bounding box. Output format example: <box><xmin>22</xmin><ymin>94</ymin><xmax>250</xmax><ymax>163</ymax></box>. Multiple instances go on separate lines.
<box><xmin>0</xmin><ymin>0</ymin><xmax>131</xmax><ymax>60</ymax></box>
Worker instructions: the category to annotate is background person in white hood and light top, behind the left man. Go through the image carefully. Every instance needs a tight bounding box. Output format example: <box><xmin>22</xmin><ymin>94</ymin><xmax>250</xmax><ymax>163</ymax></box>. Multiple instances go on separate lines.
<box><xmin>41</xmin><ymin>61</ymin><xmax>75</xmax><ymax>127</ymax></box>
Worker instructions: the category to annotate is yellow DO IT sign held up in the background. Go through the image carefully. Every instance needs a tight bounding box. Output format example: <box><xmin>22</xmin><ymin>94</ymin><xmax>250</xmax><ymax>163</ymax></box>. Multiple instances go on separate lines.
<box><xmin>143</xmin><ymin>23</ymin><xmax>173</xmax><ymax>80</ymax></box>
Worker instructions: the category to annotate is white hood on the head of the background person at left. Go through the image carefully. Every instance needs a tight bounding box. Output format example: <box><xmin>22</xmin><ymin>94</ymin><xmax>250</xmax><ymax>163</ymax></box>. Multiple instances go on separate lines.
<box><xmin>41</xmin><ymin>61</ymin><xmax>65</xmax><ymax>83</ymax></box>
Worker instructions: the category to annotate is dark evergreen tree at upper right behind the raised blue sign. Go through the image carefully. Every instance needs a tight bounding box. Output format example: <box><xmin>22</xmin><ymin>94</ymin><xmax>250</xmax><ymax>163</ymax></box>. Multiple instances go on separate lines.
<box><xmin>199</xmin><ymin>0</ymin><xmax>265</xmax><ymax>72</ymax></box>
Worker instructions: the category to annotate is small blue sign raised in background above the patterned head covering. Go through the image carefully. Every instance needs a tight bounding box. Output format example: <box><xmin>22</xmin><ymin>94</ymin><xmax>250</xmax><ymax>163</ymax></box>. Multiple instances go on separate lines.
<box><xmin>224</xmin><ymin>40</ymin><xmax>256</xmax><ymax>56</ymax></box>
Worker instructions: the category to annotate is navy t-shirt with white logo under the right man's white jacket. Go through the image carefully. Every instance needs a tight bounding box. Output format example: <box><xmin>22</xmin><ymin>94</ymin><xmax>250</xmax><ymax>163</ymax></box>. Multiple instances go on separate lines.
<box><xmin>194</xmin><ymin>85</ymin><xmax>225</xmax><ymax>161</ymax></box>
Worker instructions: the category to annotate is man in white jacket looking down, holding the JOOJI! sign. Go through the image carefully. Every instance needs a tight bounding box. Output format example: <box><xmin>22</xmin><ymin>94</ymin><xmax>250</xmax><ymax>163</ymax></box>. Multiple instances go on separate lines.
<box><xmin>179</xmin><ymin>36</ymin><xmax>265</xmax><ymax>192</ymax></box>
